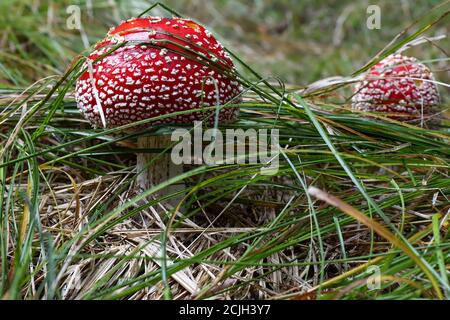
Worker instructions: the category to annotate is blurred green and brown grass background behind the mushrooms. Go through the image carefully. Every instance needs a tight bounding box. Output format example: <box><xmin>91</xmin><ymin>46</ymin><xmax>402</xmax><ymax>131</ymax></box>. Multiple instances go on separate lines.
<box><xmin>0</xmin><ymin>0</ymin><xmax>450</xmax><ymax>86</ymax></box>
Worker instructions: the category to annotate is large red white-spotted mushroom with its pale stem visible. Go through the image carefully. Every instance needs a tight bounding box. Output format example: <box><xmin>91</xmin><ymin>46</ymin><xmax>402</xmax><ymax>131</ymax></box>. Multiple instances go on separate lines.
<box><xmin>75</xmin><ymin>17</ymin><xmax>242</xmax><ymax>200</ymax></box>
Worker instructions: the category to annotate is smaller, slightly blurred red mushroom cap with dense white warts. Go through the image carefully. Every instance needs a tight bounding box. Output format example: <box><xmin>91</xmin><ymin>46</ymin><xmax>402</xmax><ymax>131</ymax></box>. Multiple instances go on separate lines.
<box><xmin>352</xmin><ymin>54</ymin><xmax>440</xmax><ymax>121</ymax></box>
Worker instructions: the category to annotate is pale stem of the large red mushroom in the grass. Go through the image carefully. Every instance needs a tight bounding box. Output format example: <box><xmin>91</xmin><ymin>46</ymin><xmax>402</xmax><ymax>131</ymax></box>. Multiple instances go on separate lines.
<box><xmin>136</xmin><ymin>136</ymin><xmax>185</xmax><ymax>206</ymax></box>
